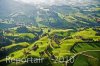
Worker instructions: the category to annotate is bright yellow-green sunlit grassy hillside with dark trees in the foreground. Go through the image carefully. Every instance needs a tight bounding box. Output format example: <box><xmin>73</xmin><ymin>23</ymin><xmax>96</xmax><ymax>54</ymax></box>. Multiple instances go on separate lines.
<box><xmin>0</xmin><ymin>28</ymin><xmax>100</xmax><ymax>66</ymax></box>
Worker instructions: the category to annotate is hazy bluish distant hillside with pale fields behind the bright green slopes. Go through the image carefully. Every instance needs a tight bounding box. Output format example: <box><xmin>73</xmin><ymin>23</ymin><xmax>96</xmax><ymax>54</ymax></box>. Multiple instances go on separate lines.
<box><xmin>0</xmin><ymin>0</ymin><xmax>100</xmax><ymax>28</ymax></box>
